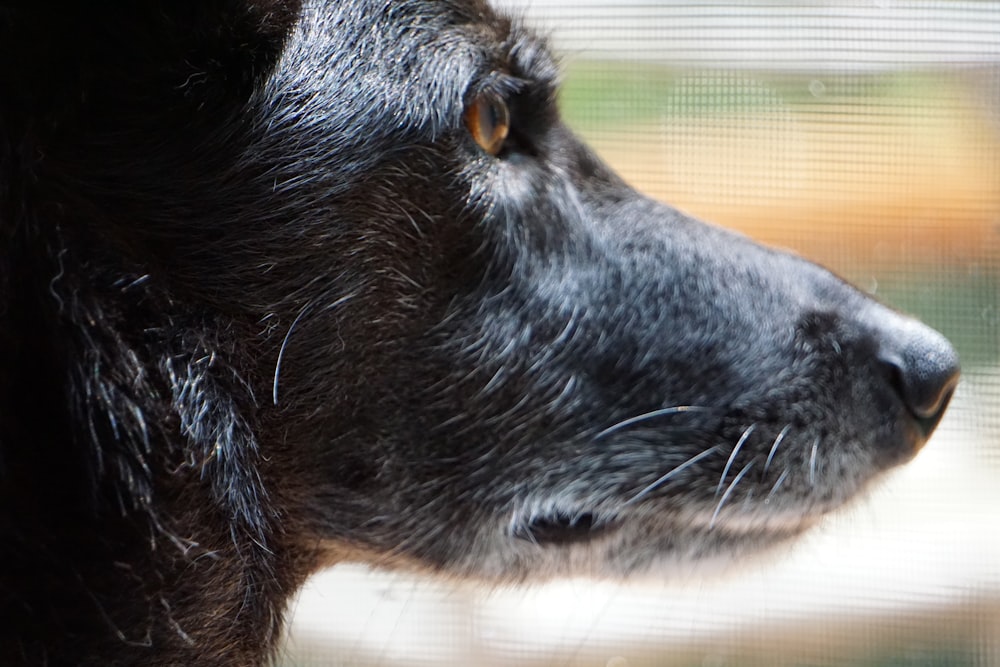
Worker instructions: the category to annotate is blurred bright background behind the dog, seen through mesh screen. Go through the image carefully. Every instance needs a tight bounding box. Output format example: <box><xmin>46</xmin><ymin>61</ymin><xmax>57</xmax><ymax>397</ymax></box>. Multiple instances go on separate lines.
<box><xmin>281</xmin><ymin>0</ymin><xmax>1000</xmax><ymax>667</ymax></box>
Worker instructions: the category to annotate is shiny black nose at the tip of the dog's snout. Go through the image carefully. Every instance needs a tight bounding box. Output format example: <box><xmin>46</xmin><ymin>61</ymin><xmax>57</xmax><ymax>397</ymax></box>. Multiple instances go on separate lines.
<box><xmin>878</xmin><ymin>315</ymin><xmax>959</xmax><ymax>436</ymax></box>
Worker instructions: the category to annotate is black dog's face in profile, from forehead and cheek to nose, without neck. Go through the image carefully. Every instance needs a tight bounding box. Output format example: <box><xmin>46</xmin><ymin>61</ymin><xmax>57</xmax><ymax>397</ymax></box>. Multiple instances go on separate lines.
<box><xmin>236</xmin><ymin>2</ymin><xmax>957</xmax><ymax>578</ymax></box>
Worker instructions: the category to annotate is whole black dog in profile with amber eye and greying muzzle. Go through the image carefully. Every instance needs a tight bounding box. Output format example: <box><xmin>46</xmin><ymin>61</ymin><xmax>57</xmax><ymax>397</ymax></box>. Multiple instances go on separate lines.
<box><xmin>0</xmin><ymin>0</ymin><xmax>957</xmax><ymax>666</ymax></box>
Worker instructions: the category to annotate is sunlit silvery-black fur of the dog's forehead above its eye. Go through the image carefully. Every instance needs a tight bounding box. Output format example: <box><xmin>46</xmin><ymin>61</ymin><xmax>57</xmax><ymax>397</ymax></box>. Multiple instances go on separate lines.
<box><xmin>266</xmin><ymin>0</ymin><xmax>552</xmax><ymax>139</ymax></box>
